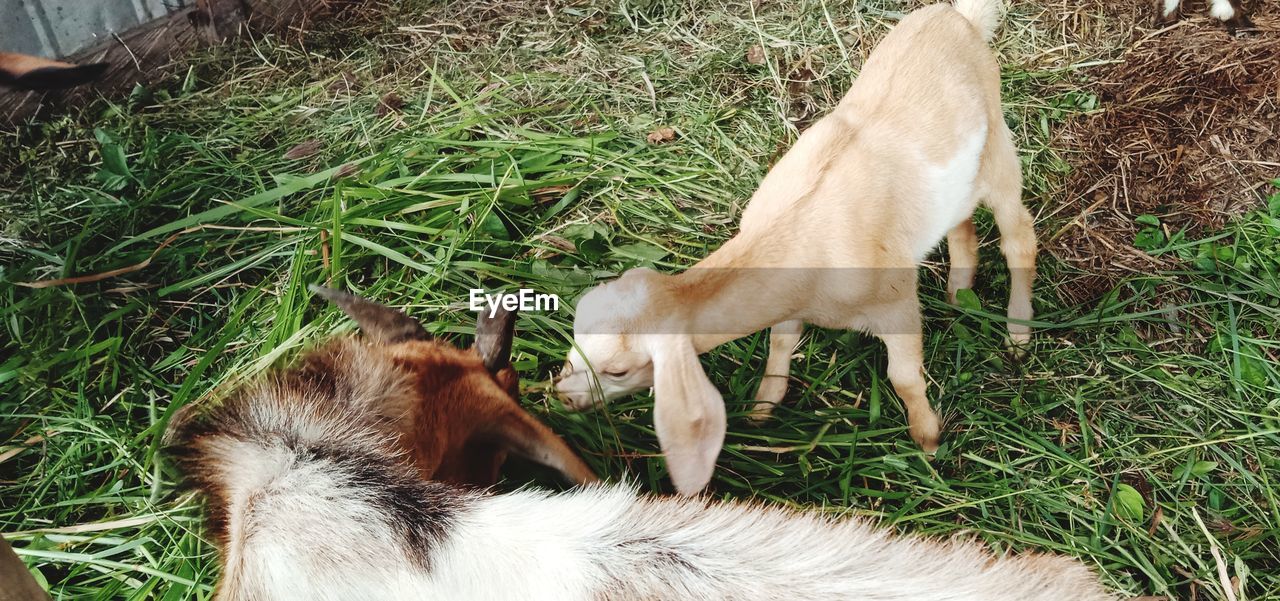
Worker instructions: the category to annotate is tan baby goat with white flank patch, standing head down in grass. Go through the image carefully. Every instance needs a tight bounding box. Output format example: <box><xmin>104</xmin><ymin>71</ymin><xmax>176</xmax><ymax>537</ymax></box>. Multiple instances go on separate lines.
<box><xmin>557</xmin><ymin>0</ymin><xmax>1036</xmax><ymax>494</ymax></box>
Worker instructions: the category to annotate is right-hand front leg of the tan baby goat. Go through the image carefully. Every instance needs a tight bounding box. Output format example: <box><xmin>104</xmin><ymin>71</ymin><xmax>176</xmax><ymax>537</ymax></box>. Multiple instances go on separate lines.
<box><xmin>865</xmin><ymin>300</ymin><xmax>942</xmax><ymax>455</ymax></box>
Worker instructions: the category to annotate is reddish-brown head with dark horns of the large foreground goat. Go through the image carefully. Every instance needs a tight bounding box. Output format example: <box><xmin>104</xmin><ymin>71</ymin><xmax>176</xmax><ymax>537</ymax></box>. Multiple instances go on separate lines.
<box><xmin>169</xmin><ymin>286</ymin><xmax>596</xmax><ymax>498</ymax></box>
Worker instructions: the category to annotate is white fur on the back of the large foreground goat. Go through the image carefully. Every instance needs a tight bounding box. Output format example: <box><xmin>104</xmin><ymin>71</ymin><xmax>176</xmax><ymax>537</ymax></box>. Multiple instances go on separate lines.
<box><xmin>217</xmin><ymin>480</ymin><xmax>1114</xmax><ymax>601</ymax></box>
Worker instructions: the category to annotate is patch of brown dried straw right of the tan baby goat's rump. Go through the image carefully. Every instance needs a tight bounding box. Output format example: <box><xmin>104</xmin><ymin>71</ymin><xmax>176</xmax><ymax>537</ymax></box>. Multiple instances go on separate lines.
<box><xmin>1044</xmin><ymin>12</ymin><xmax>1280</xmax><ymax>302</ymax></box>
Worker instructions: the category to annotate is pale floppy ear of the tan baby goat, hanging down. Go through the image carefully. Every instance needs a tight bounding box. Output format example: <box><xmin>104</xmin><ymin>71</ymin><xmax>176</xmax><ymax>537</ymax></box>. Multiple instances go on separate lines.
<box><xmin>650</xmin><ymin>335</ymin><xmax>726</xmax><ymax>495</ymax></box>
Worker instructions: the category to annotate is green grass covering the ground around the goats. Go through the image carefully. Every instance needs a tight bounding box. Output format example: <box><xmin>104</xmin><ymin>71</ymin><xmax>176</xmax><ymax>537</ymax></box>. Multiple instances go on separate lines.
<box><xmin>0</xmin><ymin>0</ymin><xmax>1280</xmax><ymax>600</ymax></box>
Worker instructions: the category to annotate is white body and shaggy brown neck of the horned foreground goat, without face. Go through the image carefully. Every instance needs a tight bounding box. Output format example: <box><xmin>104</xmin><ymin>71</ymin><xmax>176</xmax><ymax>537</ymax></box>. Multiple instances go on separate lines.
<box><xmin>177</xmin><ymin>287</ymin><xmax>1112</xmax><ymax>601</ymax></box>
